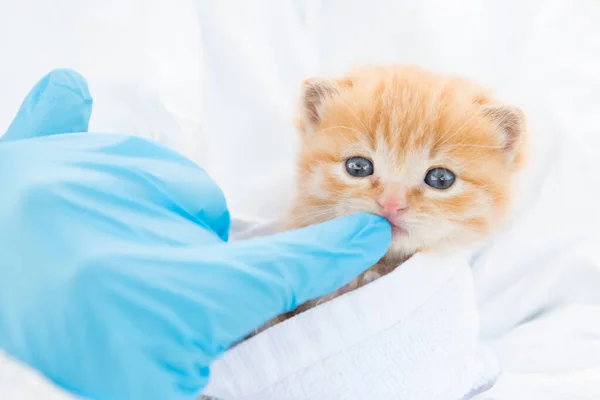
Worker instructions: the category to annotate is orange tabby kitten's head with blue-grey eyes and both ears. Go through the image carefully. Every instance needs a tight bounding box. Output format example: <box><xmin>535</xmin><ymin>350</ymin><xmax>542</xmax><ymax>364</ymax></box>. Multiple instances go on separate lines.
<box><xmin>289</xmin><ymin>68</ymin><xmax>524</xmax><ymax>258</ymax></box>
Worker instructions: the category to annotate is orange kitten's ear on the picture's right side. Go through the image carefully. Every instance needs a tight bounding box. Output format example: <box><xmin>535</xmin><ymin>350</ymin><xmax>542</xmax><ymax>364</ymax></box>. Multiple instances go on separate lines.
<box><xmin>483</xmin><ymin>105</ymin><xmax>526</xmax><ymax>159</ymax></box>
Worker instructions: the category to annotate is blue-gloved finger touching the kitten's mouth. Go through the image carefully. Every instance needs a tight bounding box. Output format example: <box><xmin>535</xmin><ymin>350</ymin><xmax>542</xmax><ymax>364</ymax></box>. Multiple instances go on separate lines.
<box><xmin>230</xmin><ymin>213</ymin><xmax>391</xmax><ymax>312</ymax></box>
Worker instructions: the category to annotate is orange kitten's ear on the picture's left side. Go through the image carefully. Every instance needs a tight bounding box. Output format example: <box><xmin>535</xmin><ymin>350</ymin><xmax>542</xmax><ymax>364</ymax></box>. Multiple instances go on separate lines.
<box><xmin>299</xmin><ymin>78</ymin><xmax>352</xmax><ymax>132</ymax></box>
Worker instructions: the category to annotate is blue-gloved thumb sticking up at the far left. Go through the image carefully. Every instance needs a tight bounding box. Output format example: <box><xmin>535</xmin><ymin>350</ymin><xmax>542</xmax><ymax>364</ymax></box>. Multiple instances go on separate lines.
<box><xmin>1</xmin><ymin>69</ymin><xmax>93</xmax><ymax>140</ymax></box>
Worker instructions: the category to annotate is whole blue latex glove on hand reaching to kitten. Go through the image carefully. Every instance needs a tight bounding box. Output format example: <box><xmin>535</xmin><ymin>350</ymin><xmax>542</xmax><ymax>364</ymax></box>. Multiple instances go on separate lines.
<box><xmin>0</xmin><ymin>70</ymin><xmax>391</xmax><ymax>400</ymax></box>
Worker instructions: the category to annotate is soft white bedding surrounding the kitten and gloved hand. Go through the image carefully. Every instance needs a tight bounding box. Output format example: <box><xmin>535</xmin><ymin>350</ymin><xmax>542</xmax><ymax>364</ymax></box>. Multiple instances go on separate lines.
<box><xmin>0</xmin><ymin>0</ymin><xmax>600</xmax><ymax>400</ymax></box>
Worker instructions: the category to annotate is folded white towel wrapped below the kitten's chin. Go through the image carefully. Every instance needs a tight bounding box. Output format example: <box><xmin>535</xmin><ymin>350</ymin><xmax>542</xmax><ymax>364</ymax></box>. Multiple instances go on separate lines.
<box><xmin>204</xmin><ymin>221</ymin><xmax>499</xmax><ymax>400</ymax></box>
